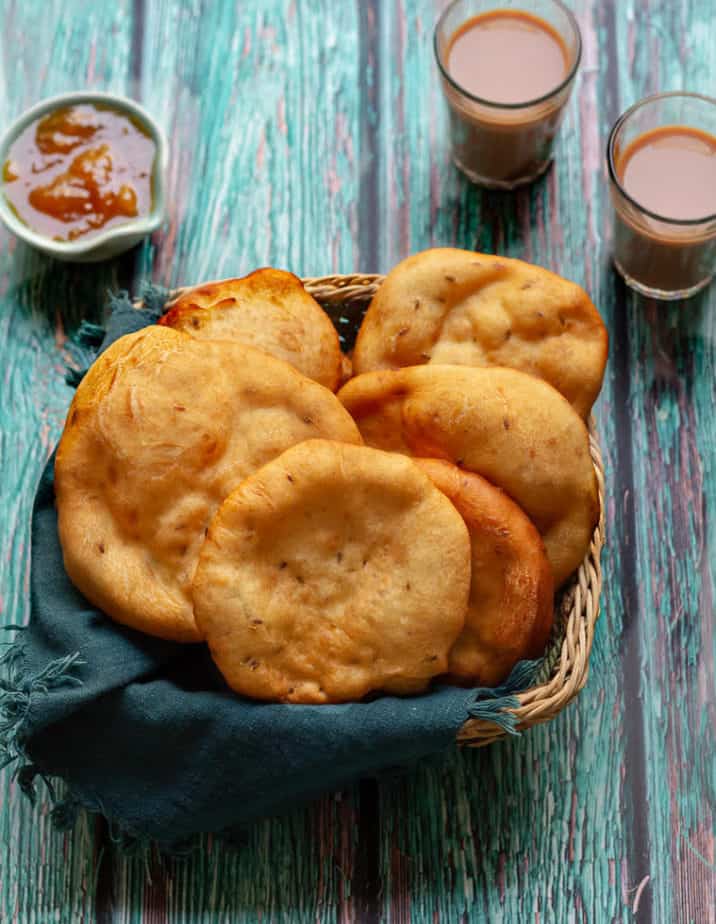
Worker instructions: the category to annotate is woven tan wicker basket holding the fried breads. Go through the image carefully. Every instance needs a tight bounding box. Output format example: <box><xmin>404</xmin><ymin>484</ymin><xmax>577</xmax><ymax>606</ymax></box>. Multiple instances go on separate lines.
<box><xmin>155</xmin><ymin>275</ymin><xmax>604</xmax><ymax>747</ymax></box>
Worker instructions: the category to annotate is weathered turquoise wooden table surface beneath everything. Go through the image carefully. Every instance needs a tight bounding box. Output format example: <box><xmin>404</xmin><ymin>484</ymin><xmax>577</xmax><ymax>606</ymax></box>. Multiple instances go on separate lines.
<box><xmin>0</xmin><ymin>0</ymin><xmax>716</xmax><ymax>924</ymax></box>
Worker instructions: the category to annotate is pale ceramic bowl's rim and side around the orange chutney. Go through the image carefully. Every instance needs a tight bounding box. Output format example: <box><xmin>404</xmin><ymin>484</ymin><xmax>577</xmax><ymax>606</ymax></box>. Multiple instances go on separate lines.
<box><xmin>0</xmin><ymin>92</ymin><xmax>167</xmax><ymax>263</ymax></box>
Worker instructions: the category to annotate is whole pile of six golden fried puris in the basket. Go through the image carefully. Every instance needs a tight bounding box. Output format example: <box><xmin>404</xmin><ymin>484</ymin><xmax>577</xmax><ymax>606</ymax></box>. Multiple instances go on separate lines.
<box><xmin>55</xmin><ymin>249</ymin><xmax>607</xmax><ymax>703</ymax></box>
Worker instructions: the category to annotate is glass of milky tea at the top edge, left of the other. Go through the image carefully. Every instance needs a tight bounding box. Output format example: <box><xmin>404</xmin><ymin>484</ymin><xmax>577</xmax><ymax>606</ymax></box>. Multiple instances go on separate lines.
<box><xmin>435</xmin><ymin>0</ymin><xmax>582</xmax><ymax>189</ymax></box>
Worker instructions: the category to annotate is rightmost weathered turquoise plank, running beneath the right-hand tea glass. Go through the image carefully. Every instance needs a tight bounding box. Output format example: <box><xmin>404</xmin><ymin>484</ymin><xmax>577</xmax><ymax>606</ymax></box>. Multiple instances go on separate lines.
<box><xmin>615</xmin><ymin>0</ymin><xmax>716</xmax><ymax>922</ymax></box>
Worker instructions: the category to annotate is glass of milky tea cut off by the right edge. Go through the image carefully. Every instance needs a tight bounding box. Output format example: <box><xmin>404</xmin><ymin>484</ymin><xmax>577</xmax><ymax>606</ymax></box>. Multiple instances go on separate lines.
<box><xmin>607</xmin><ymin>93</ymin><xmax>716</xmax><ymax>299</ymax></box>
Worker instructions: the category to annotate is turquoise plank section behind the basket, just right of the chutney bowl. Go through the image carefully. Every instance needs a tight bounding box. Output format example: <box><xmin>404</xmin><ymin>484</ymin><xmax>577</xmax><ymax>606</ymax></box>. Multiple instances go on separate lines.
<box><xmin>137</xmin><ymin>0</ymin><xmax>362</xmax><ymax>283</ymax></box>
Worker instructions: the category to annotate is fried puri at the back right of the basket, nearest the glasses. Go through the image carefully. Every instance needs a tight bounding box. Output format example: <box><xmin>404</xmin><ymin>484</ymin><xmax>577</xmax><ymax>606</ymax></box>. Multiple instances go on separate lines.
<box><xmin>353</xmin><ymin>248</ymin><xmax>608</xmax><ymax>418</ymax></box>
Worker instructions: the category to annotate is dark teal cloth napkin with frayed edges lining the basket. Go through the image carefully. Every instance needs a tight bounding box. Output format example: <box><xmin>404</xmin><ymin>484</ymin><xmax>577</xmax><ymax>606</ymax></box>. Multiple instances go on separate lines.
<box><xmin>0</xmin><ymin>294</ymin><xmax>536</xmax><ymax>845</ymax></box>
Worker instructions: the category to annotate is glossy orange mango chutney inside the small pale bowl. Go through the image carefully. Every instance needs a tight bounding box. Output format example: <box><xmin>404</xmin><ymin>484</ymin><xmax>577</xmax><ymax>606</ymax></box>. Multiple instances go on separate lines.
<box><xmin>3</xmin><ymin>104</ymin><xmax>156</xmax><ymax>241</ymax></box>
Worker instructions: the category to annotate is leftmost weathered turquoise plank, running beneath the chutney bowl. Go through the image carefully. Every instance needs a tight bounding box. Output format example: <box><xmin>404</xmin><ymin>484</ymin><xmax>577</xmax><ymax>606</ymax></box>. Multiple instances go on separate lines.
<box><xmin>0</xmin><ymin>0</ymin><xmax>136</xmax><ymax>924</ymax></box>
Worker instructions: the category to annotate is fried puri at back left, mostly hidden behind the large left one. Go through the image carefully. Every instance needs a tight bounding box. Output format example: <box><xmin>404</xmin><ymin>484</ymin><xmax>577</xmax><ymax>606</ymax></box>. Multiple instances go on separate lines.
<box><xmin>159</xmin><ymin>269</ymin><xmax>343</xmax><ymax>391</ymax></box>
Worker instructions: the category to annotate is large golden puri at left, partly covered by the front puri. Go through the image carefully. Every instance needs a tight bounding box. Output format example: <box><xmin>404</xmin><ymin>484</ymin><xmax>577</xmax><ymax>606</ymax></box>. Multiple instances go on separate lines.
<box><xmin>55</xmin><ymin>326</ymin><xmax>361</xmax><ymax>641</ymax></box>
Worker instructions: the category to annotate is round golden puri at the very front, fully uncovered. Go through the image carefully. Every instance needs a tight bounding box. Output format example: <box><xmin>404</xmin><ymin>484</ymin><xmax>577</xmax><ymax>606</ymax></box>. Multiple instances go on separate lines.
<box><xmin>194</xmin><ymin>440</ymin><xmax>470</xmax><ymax>703</ymax></box>
